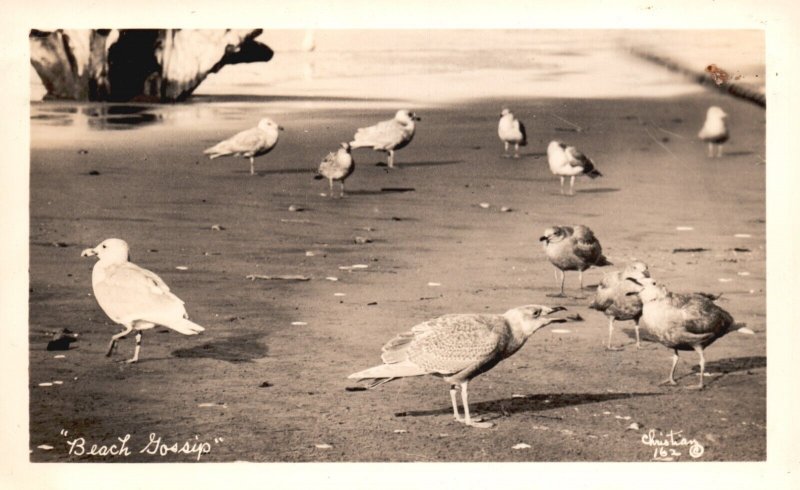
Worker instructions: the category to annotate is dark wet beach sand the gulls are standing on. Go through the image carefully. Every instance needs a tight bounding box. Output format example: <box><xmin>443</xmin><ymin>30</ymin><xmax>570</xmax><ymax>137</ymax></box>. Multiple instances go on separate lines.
<box><xmin>30</xmin><ymin>93</ymin><xmax>766</xmax><ymax>462</ymax></box>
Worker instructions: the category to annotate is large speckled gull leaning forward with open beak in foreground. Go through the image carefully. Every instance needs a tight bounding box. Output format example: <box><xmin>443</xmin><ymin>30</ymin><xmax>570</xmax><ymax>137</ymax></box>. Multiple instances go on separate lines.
<box><xmin>348</xmin><ymin>305</ymin><xmax>567</xmax><ymax>428</ymax></box>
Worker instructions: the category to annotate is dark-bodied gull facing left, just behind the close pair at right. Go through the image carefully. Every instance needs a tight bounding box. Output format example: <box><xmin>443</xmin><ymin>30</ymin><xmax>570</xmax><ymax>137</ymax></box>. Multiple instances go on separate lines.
<box><xmin>539</xmin><ymin>225</ymin><xmax>613</xmax><ymax>298</ymax></box>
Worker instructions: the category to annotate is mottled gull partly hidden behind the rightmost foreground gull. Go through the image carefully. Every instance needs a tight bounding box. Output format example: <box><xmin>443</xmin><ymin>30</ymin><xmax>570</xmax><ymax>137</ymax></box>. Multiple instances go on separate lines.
<box><xmin>589</xmin><ymin>261</ymin><xmax>650</xmax><ymax>350</ymax></box>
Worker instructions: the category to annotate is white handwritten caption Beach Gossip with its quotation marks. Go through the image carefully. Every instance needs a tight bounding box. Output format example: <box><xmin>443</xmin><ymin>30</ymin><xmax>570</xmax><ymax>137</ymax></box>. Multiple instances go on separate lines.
<box><xmin>61</xmin><ymin>430</ymin><xmax>223</xmax><ymax>461</ymax></box>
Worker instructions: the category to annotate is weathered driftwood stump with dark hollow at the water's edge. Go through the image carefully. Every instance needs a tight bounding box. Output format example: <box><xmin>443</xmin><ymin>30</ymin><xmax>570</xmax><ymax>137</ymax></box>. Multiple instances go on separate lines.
<box><xmin>29</xmin><ymin>29</ymin><xmax>273</xmax><ymax>102</ymax></box>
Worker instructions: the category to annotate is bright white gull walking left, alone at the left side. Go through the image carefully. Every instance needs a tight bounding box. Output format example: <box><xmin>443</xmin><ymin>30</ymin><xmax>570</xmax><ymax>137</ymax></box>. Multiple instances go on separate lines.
<box><xmin>81</xmin><ymin>238</ymin><xmax>205</xmax><ymax>363</ymax></box>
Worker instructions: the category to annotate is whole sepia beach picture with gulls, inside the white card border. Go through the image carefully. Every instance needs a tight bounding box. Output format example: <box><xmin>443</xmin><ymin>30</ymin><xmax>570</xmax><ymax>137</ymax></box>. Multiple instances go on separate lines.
<box><xmin>3</xmin><ymin>0</ymin><xmax>788</xmax><ymax>488</ymax></box>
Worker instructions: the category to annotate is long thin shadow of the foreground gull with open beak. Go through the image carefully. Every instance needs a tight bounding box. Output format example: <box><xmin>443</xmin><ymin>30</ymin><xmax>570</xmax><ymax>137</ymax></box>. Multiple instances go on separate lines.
<box><xmin>395</xmin><ymin>392</ymin><xmax>664</xmax><ymax>420</ymax></box>
